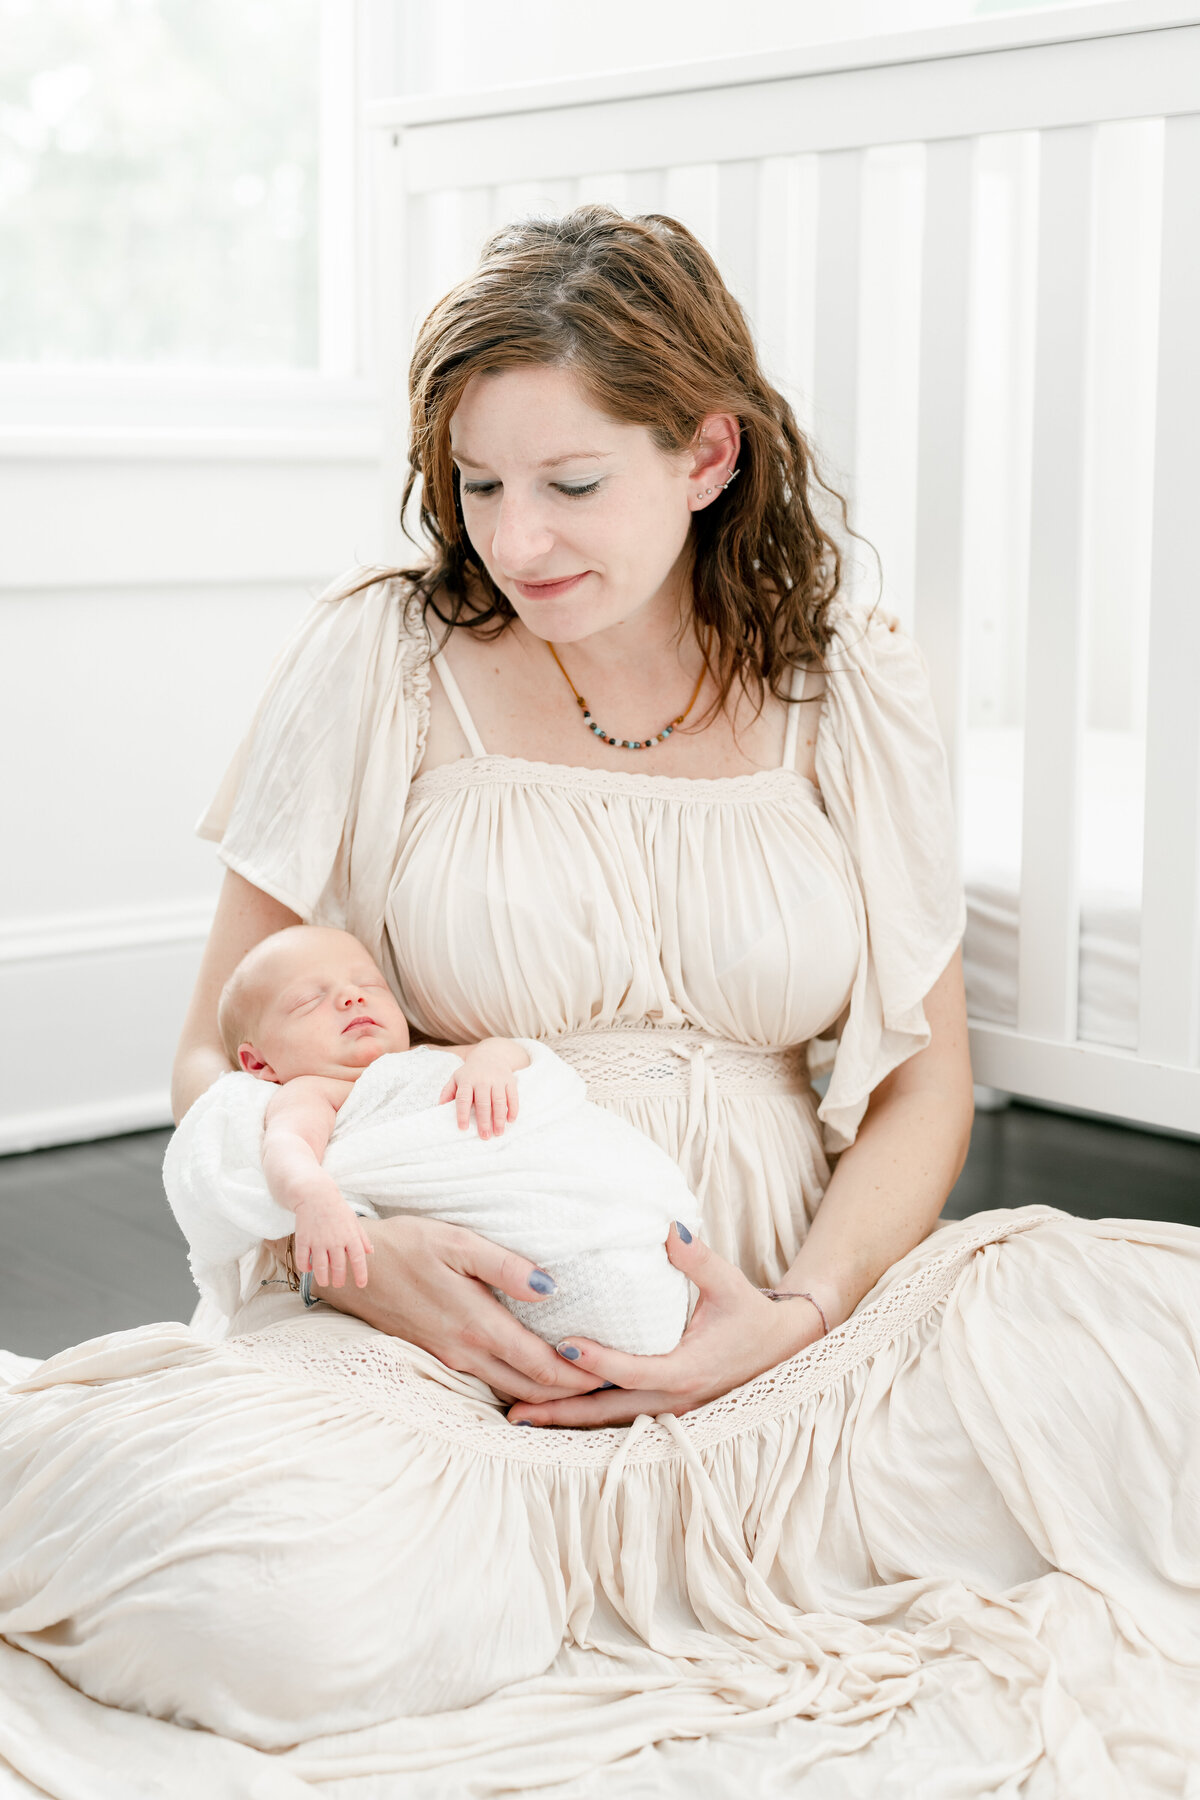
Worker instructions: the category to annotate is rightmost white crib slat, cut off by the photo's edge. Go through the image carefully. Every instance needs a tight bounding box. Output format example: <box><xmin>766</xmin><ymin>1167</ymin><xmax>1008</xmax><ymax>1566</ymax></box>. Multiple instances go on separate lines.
<box><xmin>1137</xmin><ymin>115</ymin><xmax>1200</xmax><ymax>1065</ymax></box>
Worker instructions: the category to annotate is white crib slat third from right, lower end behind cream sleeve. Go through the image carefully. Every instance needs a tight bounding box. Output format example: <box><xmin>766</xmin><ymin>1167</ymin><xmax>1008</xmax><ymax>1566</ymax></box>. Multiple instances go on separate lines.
<box><xmin>914</xmin><ymin>137</ymin><xmax>975</xmax><ymax>830</ymax></box>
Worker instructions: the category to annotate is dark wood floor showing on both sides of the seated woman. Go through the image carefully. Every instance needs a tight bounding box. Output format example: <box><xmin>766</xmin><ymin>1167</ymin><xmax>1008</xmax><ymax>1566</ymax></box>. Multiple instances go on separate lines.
<box><xmin>0</xmin><ymin>1105</ymin><xmax>1200</xmax><ymax>1355</ymax></box>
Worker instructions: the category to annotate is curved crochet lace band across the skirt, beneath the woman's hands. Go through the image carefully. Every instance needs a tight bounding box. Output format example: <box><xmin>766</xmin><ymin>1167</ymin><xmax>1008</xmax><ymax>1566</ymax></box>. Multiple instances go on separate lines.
<box><xmin>221</xmin><ymin>1208</ymin><xmax>1060</xmax><ymax>1469</ymax></box>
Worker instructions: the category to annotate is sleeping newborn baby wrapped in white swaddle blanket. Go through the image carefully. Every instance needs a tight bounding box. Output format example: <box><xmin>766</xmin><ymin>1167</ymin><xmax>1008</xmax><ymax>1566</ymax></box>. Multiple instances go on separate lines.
<box><xmin>164</xmin><ymin>925</ymin><xmax>698</xmax><ymax>1355</ymax></box>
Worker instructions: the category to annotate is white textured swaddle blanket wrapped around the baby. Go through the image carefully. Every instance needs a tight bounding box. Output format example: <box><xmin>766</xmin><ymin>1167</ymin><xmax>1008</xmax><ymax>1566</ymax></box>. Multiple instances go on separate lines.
<box><xmin>162</xmin><ymin>1039</ymin><xmax>700</xmax><ymax>1355</ymax></box>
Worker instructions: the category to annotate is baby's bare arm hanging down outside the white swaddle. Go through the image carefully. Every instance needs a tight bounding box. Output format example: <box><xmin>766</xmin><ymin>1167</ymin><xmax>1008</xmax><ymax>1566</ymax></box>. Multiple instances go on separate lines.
<box><xmin>263</xmin><ymin>1075</ymin><xmax>374</xmax><ymax>1287</ymax></box>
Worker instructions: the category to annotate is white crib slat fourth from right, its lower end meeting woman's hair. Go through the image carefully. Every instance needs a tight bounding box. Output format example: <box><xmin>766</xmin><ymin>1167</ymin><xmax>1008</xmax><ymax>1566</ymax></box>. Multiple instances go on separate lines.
<box><xmin>813</xmin><ymin>149</ymin><xmax>862</xmax><ymax>500</ymax></box>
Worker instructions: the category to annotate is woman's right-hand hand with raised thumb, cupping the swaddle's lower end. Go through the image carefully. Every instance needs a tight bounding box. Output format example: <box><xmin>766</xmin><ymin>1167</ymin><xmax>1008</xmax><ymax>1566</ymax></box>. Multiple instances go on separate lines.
<box><xmin>509</xmin><ymin>1226</ymin><xmax>822</xmax><ymax>1426</ymax></box>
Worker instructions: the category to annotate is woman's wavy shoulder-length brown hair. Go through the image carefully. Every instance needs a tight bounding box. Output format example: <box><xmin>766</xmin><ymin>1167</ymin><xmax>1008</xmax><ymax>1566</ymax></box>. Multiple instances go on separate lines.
<box><xmin>367</xmin><ymin>205</ymin><xmax>846</xmax><ymax>707</ymax></box>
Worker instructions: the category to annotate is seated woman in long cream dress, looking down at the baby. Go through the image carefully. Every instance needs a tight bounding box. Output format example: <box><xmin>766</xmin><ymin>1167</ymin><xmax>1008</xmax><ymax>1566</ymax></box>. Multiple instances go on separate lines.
<box><xmin>0</xmin><ymin>209</ymin><xmax>1200</xmax><ymax>1796</ymax></box>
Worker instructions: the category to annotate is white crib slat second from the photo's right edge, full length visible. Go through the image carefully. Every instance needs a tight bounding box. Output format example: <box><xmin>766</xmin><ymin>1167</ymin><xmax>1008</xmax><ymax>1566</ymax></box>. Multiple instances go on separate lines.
<box><xmin>1016</xmin><ymin>126</ymin><xmax>1094</xmax><ymax>1042</ymax></box>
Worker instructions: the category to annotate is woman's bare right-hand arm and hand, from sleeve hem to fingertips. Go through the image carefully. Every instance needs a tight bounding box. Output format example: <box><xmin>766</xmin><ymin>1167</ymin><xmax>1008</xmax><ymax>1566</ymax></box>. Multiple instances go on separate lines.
<box><xmin>509</xmin><ymin>952</ymin><xmax>973</xmax><ymax>1426</ymax></box>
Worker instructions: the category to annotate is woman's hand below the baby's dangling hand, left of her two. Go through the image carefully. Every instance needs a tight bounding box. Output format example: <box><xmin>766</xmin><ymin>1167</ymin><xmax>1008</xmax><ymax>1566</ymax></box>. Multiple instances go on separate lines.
<box><xmin>313</xmin><ymin>1219</ymin><xmax>600</xmax><ymax>1400</ymax></box>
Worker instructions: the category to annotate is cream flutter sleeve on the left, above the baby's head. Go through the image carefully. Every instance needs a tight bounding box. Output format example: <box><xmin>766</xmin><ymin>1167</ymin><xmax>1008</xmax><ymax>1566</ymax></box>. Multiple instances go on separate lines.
<box><xmin>198</xmin><ymin>578</ymin><xmax>430</xmax><ymax>958</ymax></box>
